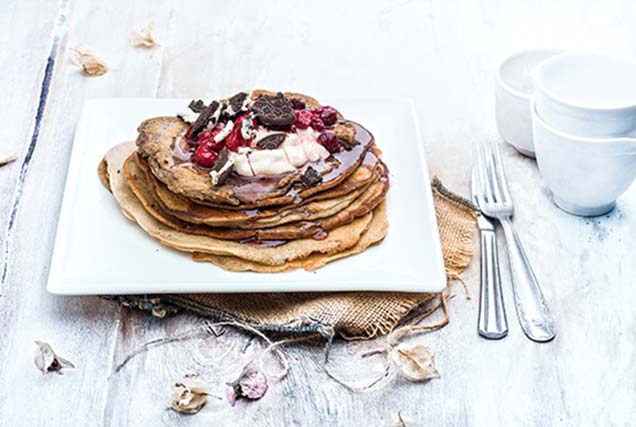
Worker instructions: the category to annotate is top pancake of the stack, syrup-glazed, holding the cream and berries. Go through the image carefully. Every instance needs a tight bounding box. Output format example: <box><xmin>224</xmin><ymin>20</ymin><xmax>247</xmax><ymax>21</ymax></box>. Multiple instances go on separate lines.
<box><xmin>136</xmin><ymin>91</ymin><xmax>373</xmax><ymax>209</ymax></box>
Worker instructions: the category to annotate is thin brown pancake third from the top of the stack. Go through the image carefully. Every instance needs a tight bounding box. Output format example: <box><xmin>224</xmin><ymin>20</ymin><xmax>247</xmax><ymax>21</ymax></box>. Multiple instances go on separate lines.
<box><xmin>123</xmin><ymin>155</ymin><xmax>388</xmax><ymax>244</ymax></box>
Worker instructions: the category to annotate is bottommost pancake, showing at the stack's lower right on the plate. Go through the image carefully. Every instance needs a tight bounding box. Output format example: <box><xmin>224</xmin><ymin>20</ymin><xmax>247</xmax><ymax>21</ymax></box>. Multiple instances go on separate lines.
<box><xmin>192</xmin><ymin>202</ymin><xmax>389</xmax><ymax>273</ymax></box>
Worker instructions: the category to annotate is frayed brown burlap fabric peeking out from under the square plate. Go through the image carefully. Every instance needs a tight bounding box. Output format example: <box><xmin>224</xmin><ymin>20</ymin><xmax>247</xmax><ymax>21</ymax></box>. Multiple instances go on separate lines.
<box><xmin>100</xmin><ymin>177</ymin><xmax>475</xmax><ymax>340</ymax></box>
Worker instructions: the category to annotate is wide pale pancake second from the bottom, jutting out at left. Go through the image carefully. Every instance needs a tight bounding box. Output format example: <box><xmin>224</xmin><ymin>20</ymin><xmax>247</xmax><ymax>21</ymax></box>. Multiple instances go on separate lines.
<box><xmin>105</xmin><ymin>142</ymin><xmax>373</xmax><ymax>265</ymax></box>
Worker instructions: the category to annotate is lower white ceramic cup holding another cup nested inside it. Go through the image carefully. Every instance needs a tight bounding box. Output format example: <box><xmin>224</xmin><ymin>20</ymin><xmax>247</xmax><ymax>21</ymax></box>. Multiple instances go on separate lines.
<box><xmin>531</xmin><ymin>99</ymin><xmax>636</xmax><ymax>216</ymax></box>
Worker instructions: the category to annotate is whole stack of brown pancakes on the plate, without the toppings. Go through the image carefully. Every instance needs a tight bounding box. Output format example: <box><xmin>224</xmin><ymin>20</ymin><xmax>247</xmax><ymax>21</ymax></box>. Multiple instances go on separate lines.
<box><xmin>99</xmin><ymin>91</ymin><xmax>389</xmax><ymax>272</ymax></box>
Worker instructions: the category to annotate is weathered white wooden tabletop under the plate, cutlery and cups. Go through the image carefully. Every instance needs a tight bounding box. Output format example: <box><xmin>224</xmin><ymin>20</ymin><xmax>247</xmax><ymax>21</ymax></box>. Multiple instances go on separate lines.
<box><xmin>0</xmin><ymin>0</ymin><xmax>636</xmax><ymax>426</ymax></box>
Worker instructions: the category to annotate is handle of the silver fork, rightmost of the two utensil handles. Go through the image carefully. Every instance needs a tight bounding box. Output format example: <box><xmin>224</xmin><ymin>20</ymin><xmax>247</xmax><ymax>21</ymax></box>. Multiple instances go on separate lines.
<box><xmin>500</xmin><ymin>218</ymin><xmax>554</xmax><ymax>342</ymax></box>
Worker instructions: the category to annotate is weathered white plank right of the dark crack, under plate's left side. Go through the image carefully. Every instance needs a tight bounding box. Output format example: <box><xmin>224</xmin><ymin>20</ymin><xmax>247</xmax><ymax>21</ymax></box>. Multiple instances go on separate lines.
<box><xmin>0</xmin><ymin>1</ymin><xmax>174</xmax><ymax>425</ymax></box>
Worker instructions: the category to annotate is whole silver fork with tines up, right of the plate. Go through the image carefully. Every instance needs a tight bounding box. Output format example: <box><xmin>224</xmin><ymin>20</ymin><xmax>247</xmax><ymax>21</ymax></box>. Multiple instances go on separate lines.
<box><xmin>475</xmin><ymin>143</ymin><xmax>554</xmax><ymax>342</ymax></box>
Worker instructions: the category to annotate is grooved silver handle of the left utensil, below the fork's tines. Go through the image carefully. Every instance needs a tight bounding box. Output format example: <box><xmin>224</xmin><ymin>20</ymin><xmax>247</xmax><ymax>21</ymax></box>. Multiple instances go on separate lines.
<box><xmin>477</xmin><ymin>230</ymin><xmax>508</xmax><ymax>339</ymax></box>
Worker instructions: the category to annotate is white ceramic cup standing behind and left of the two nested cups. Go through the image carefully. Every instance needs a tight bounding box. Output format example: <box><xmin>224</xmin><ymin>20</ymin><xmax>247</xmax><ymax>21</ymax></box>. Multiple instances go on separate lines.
<box><xmin>495</xmin><ymin>49</ymin><xmax>562</xmax><ymax>157</ymax></box>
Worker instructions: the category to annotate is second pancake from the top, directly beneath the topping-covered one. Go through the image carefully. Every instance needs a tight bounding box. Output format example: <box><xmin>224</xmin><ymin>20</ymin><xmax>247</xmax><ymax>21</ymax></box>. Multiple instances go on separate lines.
<box><xmin>137</xmin><ymin>150</ymin><xmax>385</xmax><ymax>228</ymax></box>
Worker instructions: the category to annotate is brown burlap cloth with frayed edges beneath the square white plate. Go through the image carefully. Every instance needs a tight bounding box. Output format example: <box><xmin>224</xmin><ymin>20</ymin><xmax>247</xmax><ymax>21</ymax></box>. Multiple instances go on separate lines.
<box><xmin>106</xmin><ymin>178</ymin><xmax>475</xmax><ymax>339</ymax></box>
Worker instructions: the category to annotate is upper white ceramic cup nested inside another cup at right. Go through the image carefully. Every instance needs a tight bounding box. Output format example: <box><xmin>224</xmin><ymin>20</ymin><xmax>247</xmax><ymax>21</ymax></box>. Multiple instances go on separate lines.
<box><xmin>532</xmin><ymin>52</ymin><xmax>636</xmax><ymax>138</ymax></box>
